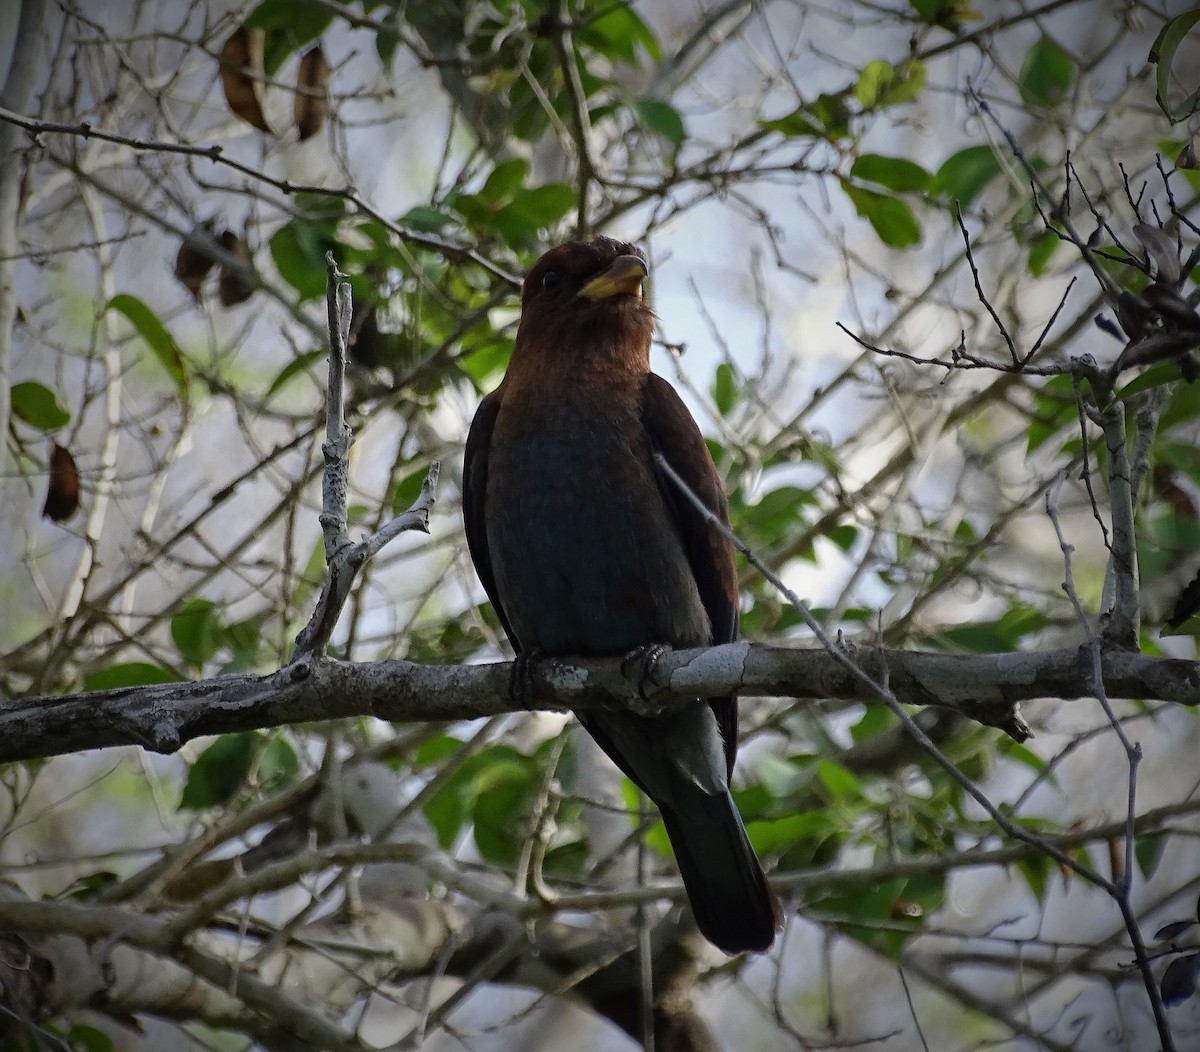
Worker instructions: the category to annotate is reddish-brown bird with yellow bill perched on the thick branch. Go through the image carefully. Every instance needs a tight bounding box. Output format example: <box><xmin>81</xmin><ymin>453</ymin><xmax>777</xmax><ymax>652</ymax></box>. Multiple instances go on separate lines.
<box><xmin>462</xmin><ymin>236</ymin><xmax>782</xmax><ymax>955</ymax></box>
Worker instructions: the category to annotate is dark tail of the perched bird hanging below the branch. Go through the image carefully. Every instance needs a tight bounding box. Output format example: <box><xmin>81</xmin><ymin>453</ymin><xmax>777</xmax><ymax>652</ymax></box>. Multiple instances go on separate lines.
<box><xmin>659</xmin><ymin>792</ymin><xmax>784</xmax><ymax>954</ymax></box>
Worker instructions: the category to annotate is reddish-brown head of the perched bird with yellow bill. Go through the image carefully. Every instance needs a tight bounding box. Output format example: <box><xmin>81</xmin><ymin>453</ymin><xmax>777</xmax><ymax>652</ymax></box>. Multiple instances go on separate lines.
<box><xmin>508</xmin><ymin>238</ymin><xmax>654</xmax><ymax>371</ymax></box>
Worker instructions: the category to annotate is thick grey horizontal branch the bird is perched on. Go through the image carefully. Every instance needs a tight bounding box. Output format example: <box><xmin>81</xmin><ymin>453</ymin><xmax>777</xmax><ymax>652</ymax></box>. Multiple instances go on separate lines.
<box><xmin>0</xmin><ymin>642</ymin><xmax>1200</xmax><ymax>763</ymax></box>
